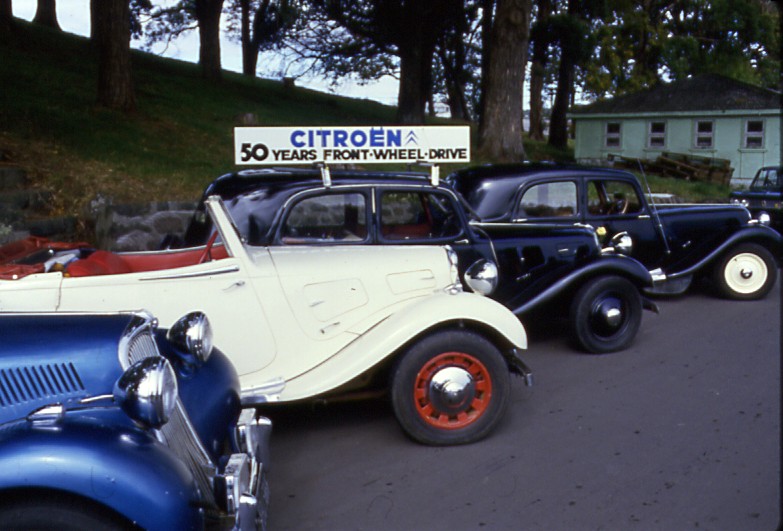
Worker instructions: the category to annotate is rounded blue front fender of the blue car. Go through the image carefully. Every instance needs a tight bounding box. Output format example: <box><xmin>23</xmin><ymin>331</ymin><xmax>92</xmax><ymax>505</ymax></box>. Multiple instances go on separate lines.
<box><xmin>0</xmin><ymin>418</ymin><xmax>203</xmax><ymax>529</ymax></box>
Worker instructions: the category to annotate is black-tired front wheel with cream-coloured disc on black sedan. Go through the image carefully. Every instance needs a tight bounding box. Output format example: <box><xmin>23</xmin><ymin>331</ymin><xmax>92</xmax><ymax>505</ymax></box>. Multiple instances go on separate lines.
<box><xmin>712</xmin><ymin>243</ymin><xmax>778</xmax><ymax>301</ymax></box>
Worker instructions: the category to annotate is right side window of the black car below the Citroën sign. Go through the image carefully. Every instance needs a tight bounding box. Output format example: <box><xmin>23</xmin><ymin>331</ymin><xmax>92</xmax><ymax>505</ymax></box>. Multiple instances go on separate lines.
<box><xmin>380</xmin><ymin>191</ymin><xmax>461</xmax><ymax>241</ymax></box>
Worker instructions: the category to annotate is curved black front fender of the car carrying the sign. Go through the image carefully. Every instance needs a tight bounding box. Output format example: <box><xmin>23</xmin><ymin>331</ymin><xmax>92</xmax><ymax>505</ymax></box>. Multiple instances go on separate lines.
<box><xmin>512</xmin><ymin>254</ymin><xmax>653</xmax><ymax>315</ymax></box>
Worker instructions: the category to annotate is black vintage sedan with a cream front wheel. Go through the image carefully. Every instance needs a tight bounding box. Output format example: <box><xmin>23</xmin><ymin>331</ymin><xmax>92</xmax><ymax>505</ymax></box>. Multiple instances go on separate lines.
<box><xmin>446</xmin><ymin>163</ymin><xmax>781</xmax><ymax>299</ymax></box>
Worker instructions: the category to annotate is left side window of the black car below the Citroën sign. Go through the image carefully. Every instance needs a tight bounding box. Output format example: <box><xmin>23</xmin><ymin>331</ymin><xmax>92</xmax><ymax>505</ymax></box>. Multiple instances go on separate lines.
<box><xmin>280</xmin><ymin>193</ymin><xmax>367</xmax><ymax>244</ymax></box>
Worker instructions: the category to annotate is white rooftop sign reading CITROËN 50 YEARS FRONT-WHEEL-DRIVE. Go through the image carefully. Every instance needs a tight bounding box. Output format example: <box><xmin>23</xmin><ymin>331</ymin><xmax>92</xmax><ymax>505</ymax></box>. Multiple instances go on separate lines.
<box><xmin>234</xmin><ymin>125</ymin><xmax>470</xmax><ymax>165</ymax></box>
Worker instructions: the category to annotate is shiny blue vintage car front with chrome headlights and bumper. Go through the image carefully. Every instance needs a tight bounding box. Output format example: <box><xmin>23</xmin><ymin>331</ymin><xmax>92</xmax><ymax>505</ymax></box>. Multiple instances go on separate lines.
<box><xmin>0</xmin><ymin>311</ymin><xmax>271</xmax><ymax>530</ymax></box>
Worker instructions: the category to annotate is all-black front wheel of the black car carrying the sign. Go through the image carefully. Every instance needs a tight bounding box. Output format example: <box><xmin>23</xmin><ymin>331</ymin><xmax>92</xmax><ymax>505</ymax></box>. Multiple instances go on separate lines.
<box><xmin>569</xmin><ymin>276</ymin><xmax>642</xmax><ymax>354</ymax></box>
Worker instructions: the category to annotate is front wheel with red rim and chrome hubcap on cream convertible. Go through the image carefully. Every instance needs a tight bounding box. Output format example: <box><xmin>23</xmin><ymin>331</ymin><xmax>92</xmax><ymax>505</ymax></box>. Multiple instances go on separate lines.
<box><xmin>391</xmin><ymin>330</ymin><xmax>511</xmax><ymax>445</ymax></box>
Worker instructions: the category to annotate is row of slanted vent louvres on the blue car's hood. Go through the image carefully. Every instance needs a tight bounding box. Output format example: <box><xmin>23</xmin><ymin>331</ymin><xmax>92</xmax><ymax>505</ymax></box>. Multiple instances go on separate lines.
<box><xmin>0</xmin><ymin>363</ymin><xmax>84</xmax><ymax>407</ymax></box>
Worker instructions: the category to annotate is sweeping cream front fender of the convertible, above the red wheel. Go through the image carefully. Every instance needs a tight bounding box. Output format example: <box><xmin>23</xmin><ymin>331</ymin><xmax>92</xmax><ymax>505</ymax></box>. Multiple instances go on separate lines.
<box><xmin>281</xmin><ymin>291</ymin><xmax>527</xmax><ymax>400</ymax></box>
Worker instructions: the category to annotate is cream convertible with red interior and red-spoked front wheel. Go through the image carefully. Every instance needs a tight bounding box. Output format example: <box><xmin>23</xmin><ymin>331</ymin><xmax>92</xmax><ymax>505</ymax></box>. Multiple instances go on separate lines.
<box><xmin>0</xmin><ymin>197</ymin><xmax>530</xmax><ymax>444</ymax></box>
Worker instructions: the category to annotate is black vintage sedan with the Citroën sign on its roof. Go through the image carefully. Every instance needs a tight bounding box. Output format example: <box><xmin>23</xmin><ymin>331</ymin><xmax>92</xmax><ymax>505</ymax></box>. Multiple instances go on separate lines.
<box><xmin>169</xmin><ymin>168</ymin><xmax>656</xmax><ymax>352</ymax></box>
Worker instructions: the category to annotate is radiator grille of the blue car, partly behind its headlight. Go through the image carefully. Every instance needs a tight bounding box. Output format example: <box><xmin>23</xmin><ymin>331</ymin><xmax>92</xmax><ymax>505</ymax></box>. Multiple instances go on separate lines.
<box><xmin>128</xmin><ymin>333</ymin><xmax>216</xmax><ymax>508</ymax></box>
